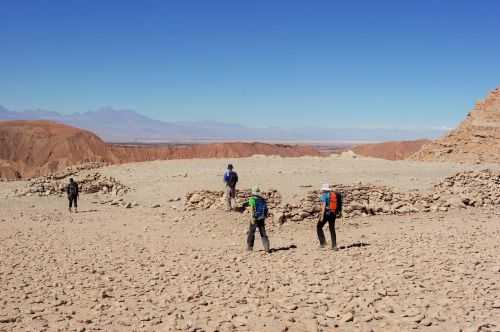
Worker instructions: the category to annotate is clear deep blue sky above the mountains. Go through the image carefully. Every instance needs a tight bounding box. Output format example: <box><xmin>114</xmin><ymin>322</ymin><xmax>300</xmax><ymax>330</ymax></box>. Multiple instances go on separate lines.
<box><xmin>0</xmin><ymin>0</ymin><xmax>500</xmax><ymax>128</ymax></box>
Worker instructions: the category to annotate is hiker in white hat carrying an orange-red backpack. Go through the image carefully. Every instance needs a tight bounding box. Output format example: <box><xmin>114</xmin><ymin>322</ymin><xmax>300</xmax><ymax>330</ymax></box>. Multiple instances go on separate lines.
<box><xmin>316</xmin><ymin>184</ymin><xmax>342</xmax><ymax>251</ymax></box>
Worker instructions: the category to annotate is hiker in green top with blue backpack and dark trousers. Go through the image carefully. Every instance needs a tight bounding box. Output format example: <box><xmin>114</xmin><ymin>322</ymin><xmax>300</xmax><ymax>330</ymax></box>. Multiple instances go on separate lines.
<box><xmin>247</xmin><ymin>187</ymin><xmax>270</xmax><ymax>253</ymax></box>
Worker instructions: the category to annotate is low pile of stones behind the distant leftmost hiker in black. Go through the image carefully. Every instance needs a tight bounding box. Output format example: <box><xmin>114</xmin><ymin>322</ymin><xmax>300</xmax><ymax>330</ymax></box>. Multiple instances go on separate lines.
<box><xmin>24</xmin><ymin>172</ymin><xmax>130</xmax><ymax>196</ymax></box>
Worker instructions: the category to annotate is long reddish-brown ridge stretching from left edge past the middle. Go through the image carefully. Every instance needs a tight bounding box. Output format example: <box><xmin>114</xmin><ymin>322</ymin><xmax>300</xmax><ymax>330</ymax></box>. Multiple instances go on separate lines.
<box><xmin>0</xmin><ymin>121</ymin><xmax>320</xmax><ymax>179</ymax></box>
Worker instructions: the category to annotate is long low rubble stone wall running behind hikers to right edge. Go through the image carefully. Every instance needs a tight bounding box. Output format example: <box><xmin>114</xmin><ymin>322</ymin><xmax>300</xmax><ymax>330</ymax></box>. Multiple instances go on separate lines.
<box><xmin>185</xmin><ymin>170</ymin><xmax>500</xmax><ymax>223</ymax></box>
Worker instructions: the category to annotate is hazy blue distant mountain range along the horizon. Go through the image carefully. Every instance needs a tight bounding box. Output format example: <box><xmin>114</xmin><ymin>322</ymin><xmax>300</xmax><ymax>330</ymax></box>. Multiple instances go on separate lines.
<box><xmin>0</xmin><ymin>106</ymin><xmax>446</xmax><ymax>143</ymax></box>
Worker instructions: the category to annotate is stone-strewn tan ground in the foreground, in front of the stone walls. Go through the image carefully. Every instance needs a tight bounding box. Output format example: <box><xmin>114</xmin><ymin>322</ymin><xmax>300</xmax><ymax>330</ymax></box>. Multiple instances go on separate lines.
<box><xmin>0</xmin><ymin>201</ymin><xmax>500</xmax><ymax>331</ymax></box>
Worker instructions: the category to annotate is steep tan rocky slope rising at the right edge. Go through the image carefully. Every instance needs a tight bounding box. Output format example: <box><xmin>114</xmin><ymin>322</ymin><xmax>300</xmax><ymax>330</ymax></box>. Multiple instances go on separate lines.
<box><xmin>410</xmin><ymin>88</ymin><xmax>500</xmax><ymax>163</ymax></box>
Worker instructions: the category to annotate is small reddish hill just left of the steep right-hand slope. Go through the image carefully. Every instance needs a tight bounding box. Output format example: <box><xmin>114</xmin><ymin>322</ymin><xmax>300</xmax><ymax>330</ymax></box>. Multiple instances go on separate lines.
<box><xmin>352</xmin><ymin>139</ymin><xmax>431</xmax><ymax>160</ymax></box>
